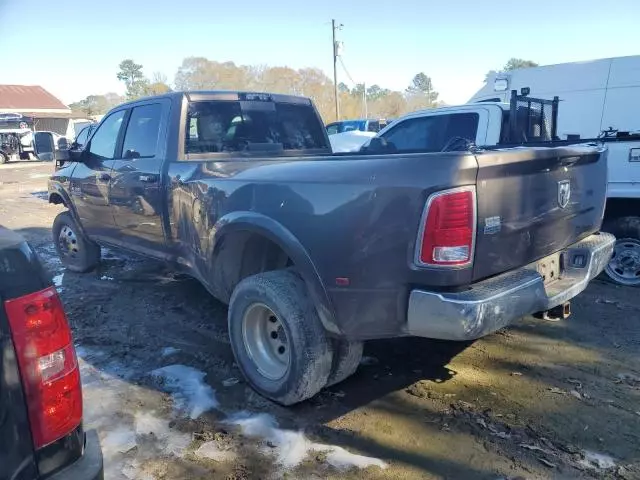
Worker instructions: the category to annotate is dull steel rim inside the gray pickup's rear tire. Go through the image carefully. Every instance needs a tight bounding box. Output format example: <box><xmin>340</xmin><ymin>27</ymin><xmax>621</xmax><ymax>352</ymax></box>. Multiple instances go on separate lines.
<box><xmin>242</xmin><ymin>303</ymin><xmax>291</xmax><ymax>380</ymax></box>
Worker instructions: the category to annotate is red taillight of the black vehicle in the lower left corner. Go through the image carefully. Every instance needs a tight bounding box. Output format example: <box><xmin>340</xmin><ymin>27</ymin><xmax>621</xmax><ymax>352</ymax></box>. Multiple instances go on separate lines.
<box><xmin>5</xmin><ymin>287</ymin><xmax>82</xmax><ymax>449</ymax></box>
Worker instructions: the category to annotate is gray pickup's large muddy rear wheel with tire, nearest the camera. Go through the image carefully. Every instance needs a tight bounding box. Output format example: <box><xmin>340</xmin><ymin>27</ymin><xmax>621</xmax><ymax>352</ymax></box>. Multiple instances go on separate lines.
<box><xmin>228</xmin><ymin>270</ymin><xmax>332</xmax><ymax>405</ymax></box>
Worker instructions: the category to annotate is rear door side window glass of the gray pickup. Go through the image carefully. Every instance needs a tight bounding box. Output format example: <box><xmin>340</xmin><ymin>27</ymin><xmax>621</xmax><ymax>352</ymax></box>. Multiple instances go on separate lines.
<box><xmin>122</xmin><ymin>103</ymin><xmax>162</xmax><ymax>158</ymax></box>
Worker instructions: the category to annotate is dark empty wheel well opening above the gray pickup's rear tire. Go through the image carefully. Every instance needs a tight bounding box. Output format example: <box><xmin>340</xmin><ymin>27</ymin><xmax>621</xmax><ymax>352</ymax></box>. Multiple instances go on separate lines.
<box><xmin>212</xmin><ymin>231</ymin><xmax>293</xmax><ymax>303</ymax></box>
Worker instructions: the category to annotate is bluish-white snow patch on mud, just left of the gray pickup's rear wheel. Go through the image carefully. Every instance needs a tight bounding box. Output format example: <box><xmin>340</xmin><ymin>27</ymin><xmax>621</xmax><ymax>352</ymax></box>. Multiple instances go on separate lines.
<box><xmin>151</xmin><ymin>365</ymin><xmax>218</xmax><ymax>419</ymax></box>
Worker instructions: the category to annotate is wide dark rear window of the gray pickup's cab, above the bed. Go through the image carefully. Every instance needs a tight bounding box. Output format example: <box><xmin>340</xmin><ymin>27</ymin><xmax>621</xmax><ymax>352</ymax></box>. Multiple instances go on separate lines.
<box><xmin>184</xmin><ymin>95</ymin><xmax>330</xmax><ymax>155</ymax></box>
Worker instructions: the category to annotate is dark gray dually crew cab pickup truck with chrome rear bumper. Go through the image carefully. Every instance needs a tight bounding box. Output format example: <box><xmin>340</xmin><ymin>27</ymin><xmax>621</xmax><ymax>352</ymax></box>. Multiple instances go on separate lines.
<box><xmin>49</xmin><ymin>92</ymin><xmax>614</xmax><ymax>404</ymax></box>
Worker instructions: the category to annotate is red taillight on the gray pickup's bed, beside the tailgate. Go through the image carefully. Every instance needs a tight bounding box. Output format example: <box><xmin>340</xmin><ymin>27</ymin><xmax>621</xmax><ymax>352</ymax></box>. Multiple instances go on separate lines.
<box><xmin>419</xmin><ymin>189</ymin><xmax>475</xmax><ymax>265</ymax></box>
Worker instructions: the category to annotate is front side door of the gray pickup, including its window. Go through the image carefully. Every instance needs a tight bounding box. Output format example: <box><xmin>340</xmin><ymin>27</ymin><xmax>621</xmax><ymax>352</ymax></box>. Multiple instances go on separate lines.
<box><xmin>70</xmin><ymin>109</ymin><xmax>127</xmax><ymax>239</ymax></box>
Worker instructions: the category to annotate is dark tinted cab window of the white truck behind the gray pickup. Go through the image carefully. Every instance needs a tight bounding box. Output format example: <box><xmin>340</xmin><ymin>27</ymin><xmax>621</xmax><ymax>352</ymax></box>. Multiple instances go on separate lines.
<box><xmin>383</xmin><ymin>113</ymin><xmax>479</xmax><ymax>152</ymax></box>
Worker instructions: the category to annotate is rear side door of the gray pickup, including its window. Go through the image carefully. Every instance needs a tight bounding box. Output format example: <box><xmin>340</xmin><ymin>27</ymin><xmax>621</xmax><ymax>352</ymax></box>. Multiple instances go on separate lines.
<box><xmin>109</xmin><ymin>99</ymin><xmax>171</xmax><ymax>254</ymax></box>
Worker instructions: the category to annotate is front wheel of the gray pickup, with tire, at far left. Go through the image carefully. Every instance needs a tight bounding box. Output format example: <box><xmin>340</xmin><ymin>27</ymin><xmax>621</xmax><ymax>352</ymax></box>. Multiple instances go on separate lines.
<box><xmin>51</xmin><ymin>212</ymin><xmax>101</xmax><ymax>273</ymax></box>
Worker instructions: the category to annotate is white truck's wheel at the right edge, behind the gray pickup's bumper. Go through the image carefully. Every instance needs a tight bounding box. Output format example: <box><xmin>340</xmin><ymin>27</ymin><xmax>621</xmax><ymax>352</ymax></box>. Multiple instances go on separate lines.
<box><xmin>602</xmin><ymin>217</ymin><xmax>640</xmax><ymax>287</ymax></box>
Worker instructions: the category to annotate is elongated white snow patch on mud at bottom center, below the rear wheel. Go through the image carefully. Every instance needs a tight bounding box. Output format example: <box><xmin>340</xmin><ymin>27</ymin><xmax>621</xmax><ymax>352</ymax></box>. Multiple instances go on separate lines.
<box><xmin>228</xmin><ymin>412</ymin><xmax>387</xmax><ymax>469</ymax></box>
